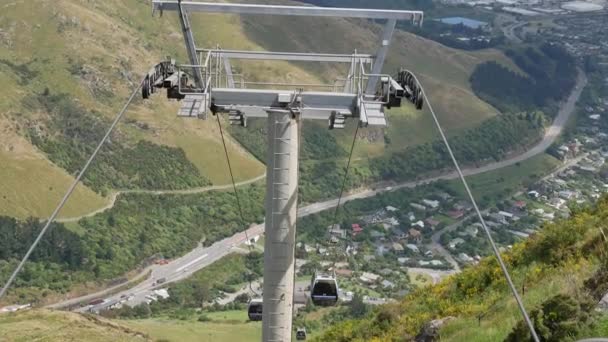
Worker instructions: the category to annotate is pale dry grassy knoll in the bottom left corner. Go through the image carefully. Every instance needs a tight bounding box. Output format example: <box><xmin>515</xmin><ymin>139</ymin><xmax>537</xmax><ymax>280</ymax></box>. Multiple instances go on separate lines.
<box><xmin>0</xmin><ymin>310</ymin><xmax>152</xmax><ymax>342</ymax></box>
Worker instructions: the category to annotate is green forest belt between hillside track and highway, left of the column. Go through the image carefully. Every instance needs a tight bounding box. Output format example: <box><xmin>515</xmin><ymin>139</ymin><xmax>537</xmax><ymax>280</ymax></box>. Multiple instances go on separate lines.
<box><xmin>0</xmin><ymin>186</ymin><xmax>264</xmax><ymax>302</ymax></box>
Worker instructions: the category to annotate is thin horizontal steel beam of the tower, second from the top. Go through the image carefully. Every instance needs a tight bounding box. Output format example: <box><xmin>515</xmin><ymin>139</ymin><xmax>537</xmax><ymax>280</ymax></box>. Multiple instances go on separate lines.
<box><xmin>197</xmin><ymin>49</ymin><xmax>374</xmax><ymax>64</ymax></box>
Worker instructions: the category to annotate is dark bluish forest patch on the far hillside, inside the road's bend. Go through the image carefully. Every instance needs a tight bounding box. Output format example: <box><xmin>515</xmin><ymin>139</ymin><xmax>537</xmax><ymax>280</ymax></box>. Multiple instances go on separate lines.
<box><xmin>470</xmin><ymin>43</ymin><xmax>577</xmax><ymax>113</ymax></box>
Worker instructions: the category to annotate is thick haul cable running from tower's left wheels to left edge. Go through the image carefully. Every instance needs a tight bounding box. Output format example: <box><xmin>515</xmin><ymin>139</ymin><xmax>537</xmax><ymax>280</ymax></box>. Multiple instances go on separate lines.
<box><xmin>0</xmin><ymin>80</ymin><xmax>144</xmax><ymax>298</ymax></box>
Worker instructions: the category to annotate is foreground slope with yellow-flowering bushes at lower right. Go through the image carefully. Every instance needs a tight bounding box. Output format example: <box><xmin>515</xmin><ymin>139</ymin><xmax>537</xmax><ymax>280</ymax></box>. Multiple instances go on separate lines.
<box><xmin>319</xmin><ymin>198</ymin><xmax>608</xmax><ymax>341</ymax></box>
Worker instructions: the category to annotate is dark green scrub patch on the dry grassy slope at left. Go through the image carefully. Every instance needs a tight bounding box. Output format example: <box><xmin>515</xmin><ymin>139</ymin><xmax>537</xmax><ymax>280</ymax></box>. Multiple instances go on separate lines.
<box><xmin>24</xmin><ymin>91</ymin><xmax>209</xmax><ymax>192</ymax></box>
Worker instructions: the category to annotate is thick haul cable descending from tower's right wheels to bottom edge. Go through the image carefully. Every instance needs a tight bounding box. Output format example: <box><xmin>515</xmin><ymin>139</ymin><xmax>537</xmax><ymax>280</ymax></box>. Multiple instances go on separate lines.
<box><xmin>408</xmin><ymin>71</ymin><xmax>540</xmax><ymax>342</ymax></box>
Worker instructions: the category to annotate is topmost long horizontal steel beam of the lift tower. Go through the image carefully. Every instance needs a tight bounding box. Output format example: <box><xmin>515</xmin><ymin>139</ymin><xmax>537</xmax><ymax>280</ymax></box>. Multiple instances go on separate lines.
<box><xmin>152</xmin><ymin>0</ymin><xmax>423</xmax><ymax>22</ymax></box>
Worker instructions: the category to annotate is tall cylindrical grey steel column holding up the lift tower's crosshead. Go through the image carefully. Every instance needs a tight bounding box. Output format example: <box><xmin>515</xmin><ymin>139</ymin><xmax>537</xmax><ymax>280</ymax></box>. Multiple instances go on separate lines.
<box><xmin>262</xmin><ymin>110</ymin><xmax>300</xmax><ymax>342</ymax></box>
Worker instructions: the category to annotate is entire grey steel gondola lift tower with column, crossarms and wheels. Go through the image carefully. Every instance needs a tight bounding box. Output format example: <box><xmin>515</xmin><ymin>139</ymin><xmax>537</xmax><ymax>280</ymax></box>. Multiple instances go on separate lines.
<box><xmin>142</xmin><ymin>0</ymin><xmax>423</xmax><ymax>342</ymax></box>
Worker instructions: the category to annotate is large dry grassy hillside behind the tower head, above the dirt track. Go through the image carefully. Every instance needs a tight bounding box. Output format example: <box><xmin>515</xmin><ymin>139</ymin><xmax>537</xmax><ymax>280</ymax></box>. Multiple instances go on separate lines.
<box><xmin>0</xmin><ymin>0</ymin><xmax>513</xmax><ymax>218</ymax></box>
